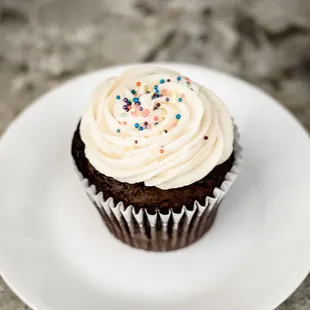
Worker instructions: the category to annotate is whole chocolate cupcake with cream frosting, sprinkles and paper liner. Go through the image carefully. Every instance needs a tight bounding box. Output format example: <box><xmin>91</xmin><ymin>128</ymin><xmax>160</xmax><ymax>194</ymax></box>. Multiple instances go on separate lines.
<box><xmin>71</xmin><ymin>66</ymin><xmax>241</xmax><ymax>251</ymax></box>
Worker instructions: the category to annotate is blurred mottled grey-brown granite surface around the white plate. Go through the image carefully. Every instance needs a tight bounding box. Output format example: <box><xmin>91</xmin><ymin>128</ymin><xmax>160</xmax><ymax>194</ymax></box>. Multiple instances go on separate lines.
<box><xmin>0</xmin><ymin>0</ymin><xmax>310</xmax><ymax>310</ymax></box>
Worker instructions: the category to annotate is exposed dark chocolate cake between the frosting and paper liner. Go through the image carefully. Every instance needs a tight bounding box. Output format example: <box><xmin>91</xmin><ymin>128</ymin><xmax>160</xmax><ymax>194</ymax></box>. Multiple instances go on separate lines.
<box><xmin>72</xmin><ymin>126</ymin><xmax>235</xmax><ymax>212</ymax></box>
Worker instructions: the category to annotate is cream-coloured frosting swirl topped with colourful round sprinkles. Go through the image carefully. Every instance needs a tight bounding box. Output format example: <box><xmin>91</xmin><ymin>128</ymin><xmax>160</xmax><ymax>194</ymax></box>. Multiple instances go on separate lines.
<box><xmin>80</xmin><ymin>67</ymin><xmax>234</xmax><ymax>190</ymax></box>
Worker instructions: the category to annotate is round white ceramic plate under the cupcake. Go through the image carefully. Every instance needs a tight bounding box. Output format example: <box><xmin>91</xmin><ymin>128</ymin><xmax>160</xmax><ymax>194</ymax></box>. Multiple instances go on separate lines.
<box><xmin>0</xmin><ymin>64</ymin><xmax>310</xmax><ymax>310</ymax></box>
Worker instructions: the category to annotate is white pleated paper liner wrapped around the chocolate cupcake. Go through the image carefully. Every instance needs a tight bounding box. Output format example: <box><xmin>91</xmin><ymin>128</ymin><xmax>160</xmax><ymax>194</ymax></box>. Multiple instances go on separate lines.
<box><xmin>74</xmin><ymin>126</ymin><xmax>242</xmax><ymax>251</ymax></box>
